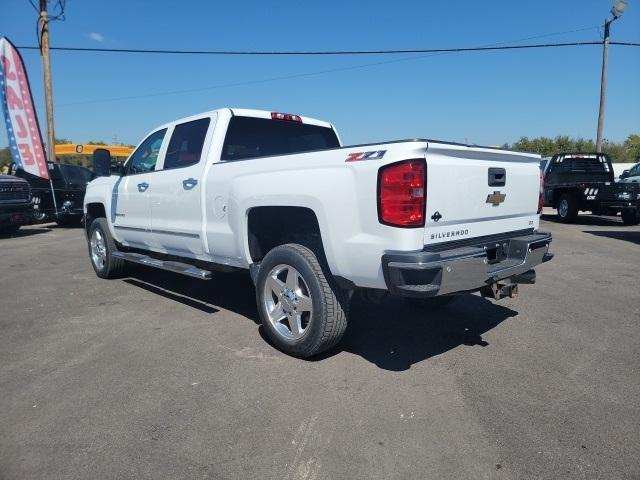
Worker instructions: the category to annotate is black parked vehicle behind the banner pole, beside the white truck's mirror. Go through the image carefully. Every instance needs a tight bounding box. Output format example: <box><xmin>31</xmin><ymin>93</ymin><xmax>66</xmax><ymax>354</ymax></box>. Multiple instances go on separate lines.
<box><xmin>12</xmin><ymin>162</ymin><xmax>94</xmax><ymax>226</ymax></box>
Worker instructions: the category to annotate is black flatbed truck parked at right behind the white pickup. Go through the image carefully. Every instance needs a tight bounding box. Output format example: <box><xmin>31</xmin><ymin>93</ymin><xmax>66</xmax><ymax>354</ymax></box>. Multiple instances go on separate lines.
<box><xmin>544</xmin><ymin>152</ymin><xmax>640</xmax><ymax>225</ymax></box>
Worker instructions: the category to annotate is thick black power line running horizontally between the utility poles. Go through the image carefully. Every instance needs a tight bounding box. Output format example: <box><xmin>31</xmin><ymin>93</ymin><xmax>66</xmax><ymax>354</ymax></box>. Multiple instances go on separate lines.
<box><xmin>18</xmin><ymin>41</ymin><xmax>640</xmax><ymax>56</ymax></box>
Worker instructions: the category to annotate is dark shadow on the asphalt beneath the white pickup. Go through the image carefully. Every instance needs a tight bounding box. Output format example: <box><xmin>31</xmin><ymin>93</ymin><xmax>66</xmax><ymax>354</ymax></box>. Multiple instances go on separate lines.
<box><xmin>124</xmin><ymin>266</ymin><xmax>518</xmax><ymax>371</ymax></box>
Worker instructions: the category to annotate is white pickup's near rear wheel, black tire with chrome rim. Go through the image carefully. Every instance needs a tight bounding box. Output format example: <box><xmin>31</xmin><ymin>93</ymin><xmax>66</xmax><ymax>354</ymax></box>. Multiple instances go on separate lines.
<box><xmin>256</xmin><ymin>243</ymin><xmax>349</xmax><ymax>358</ymax></box>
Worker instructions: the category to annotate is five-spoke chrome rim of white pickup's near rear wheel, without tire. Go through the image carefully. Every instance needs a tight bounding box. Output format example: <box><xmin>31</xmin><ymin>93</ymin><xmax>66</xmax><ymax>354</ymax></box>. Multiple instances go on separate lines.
<box><xmin>263</xmin><ymin>264</ymin><xmax>313</xmax><ymax>340</ymax></box>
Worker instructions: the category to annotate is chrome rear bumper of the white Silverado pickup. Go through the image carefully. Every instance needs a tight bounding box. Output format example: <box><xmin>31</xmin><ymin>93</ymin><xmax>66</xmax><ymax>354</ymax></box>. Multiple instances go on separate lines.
<box><xmin>382</xmin><ymin>232</ymin><xmax>553</xmax><ymax>297</ymax></box>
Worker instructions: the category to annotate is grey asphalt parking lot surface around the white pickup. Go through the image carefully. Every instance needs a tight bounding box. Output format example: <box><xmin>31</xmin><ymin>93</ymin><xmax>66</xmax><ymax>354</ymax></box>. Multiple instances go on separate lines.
<box><xmin>0</xmin><ymin>216</ymin><xmax>640</xmax><ymax>480</ymax></box>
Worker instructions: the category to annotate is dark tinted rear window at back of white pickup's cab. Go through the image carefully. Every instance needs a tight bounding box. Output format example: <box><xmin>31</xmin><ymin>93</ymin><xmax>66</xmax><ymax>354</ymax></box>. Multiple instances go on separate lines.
<box><xmin>221</xmin><ymin>116</ymin><xmax>340</xmax><ymax>161</ymax></box>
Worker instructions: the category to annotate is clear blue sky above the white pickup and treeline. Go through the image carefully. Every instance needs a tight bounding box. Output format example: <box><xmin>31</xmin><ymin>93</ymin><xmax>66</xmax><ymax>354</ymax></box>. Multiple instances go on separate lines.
<box><xmin>0</xmin><ymin>0</ymin><xmax>640</xmax><ymax>147</ymax></box>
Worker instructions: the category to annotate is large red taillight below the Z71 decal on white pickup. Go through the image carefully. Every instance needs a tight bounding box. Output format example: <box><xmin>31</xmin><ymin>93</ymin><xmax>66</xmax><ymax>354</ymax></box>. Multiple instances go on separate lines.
<box><xmin>378</xmin><ymin>160</ymin><xmax>426</xmax><ymax>227</ymax></box>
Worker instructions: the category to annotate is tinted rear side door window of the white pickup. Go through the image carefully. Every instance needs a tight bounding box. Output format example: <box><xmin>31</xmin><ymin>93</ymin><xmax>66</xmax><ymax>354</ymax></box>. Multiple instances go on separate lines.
<box><xmin>163</xmin><ymin>117</ymin><xmax>211</xmax><ymax>170</ymax></box>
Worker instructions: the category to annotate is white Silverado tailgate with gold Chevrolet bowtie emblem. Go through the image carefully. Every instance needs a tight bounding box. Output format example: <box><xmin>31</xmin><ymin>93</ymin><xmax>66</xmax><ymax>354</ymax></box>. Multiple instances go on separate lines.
<box><xmin>424</xmin><ymin>143</ymin><xmax>540</xmax><ymax>245</ymax></box>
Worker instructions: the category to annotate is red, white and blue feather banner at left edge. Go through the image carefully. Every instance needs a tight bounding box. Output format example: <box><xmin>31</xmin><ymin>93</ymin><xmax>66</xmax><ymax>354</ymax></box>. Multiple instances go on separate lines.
<box><xmin>0</xmin><ymin>38</ymin><xmax>49</xmax><ymax>179</ymax></box>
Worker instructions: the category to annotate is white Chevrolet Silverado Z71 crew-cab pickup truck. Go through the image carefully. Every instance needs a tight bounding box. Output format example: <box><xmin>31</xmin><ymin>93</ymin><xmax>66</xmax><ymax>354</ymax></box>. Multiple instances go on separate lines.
<box><xmin>84</xmin><ymin>108</ymin><xmax>552</xmax><ymax>357</ymax></box>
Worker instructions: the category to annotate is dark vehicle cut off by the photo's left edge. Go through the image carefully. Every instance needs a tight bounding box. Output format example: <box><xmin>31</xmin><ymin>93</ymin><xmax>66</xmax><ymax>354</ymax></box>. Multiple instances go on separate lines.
<box><xmin>0</xmin><ymin>175</ymin><xmax>33</xmax><ymax>235</ymax></box>
